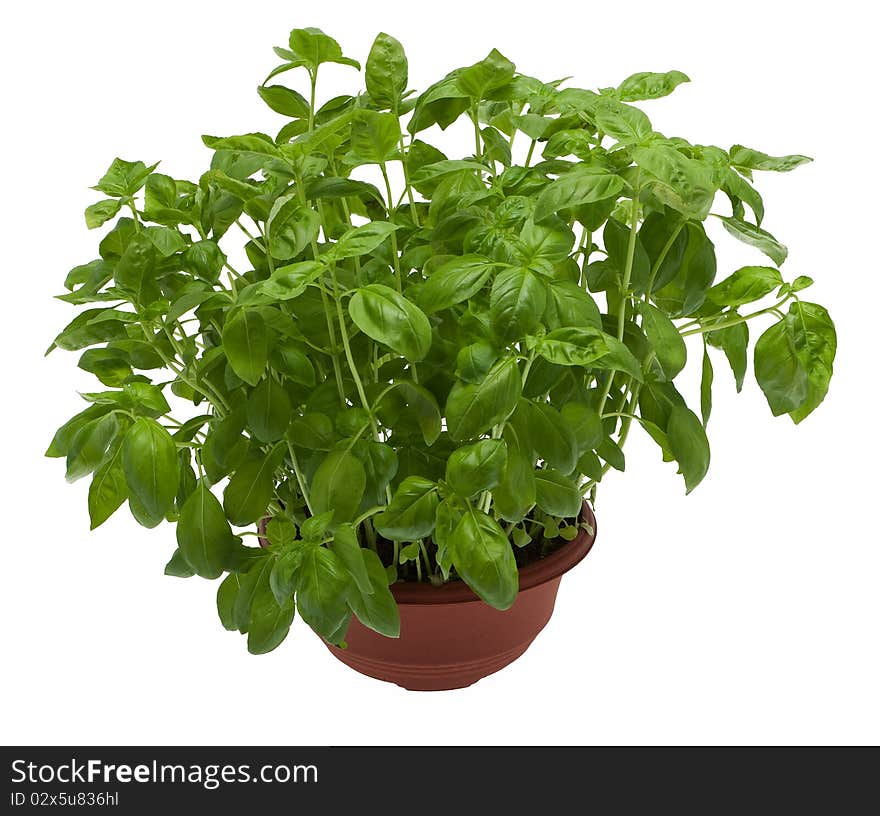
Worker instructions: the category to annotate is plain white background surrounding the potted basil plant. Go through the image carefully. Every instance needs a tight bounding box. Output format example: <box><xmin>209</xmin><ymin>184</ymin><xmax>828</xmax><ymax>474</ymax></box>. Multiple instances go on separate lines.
<box><xmin>0</xmin><ymin>0</ymin><xmax>880</xmax><ymax>744</ymax></box>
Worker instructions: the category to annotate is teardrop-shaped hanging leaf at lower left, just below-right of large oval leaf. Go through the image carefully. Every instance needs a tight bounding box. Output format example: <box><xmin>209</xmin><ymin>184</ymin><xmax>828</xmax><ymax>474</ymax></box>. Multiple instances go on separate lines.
<box><xmin>177</xmin><ymin>480</ymin><xmax>237</xmax><ymax>578</ymax></box>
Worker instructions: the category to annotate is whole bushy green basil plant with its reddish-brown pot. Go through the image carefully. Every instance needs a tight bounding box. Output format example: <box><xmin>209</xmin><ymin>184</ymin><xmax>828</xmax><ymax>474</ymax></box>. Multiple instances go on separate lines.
<box><xmin>47</xmin><ymin>29</ymin><xmax>836</xmax><ymax>689</ymax></box>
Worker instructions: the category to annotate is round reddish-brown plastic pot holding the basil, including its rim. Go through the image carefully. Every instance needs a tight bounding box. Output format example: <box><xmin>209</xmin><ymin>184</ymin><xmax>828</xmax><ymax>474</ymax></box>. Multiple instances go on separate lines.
<box><xmin>327</xmin><ymin>502</ymin><xmax>596</xmax><ymax>691</ymax></box>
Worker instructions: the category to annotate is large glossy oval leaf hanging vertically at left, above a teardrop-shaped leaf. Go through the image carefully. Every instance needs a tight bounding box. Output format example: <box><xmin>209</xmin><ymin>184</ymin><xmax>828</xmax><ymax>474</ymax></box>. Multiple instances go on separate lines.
<box><xmin>122</xmin><ymin>417</ymin><xmax>179</xmax><ymax>520</ymax></box>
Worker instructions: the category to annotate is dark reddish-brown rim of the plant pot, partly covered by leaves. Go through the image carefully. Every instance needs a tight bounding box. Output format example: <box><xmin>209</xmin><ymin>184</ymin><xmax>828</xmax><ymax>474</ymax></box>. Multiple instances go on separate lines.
<box><xmin>389</xmin><ymin>501</ymin><xmax>596</xmax><ymax>605</ymax></box>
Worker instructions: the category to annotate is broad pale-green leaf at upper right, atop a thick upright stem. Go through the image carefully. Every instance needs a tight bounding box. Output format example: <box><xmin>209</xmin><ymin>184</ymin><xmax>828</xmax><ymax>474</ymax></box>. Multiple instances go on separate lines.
<box><xmin>633</xmin><ymin>145</ymin><xmax>717</xmax><ymax>221</ymax></box>
